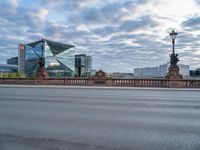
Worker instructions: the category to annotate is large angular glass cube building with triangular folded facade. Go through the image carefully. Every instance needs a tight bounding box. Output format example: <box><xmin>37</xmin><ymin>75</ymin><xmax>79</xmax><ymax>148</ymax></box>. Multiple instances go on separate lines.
<box><xmin>25</xmin><ymin>39</ymin><xmax>75</xmax><ymax>77</ymax></box>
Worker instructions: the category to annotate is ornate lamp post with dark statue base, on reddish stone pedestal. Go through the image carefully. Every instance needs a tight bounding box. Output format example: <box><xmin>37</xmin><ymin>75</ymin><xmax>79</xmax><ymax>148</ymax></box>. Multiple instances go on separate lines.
<box><xmin>166</xmin><ymin>29</ymin><xmax>182</xmax><ymax>80</ymax></box>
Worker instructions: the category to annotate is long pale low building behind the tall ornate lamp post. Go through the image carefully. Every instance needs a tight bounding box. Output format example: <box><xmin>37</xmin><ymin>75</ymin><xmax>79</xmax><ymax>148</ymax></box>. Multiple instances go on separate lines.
<box><xmin>134</xmin><ymin>63</ymin><xmax>190</xmax><ymax>77</ymax></box>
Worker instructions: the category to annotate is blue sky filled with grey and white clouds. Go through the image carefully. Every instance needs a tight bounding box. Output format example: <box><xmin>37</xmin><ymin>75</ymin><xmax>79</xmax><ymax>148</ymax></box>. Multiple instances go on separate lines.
<box><xmin>0</xmin><ymin>0</ymin><xmax>200</xmax><ymax>72</ymax></box>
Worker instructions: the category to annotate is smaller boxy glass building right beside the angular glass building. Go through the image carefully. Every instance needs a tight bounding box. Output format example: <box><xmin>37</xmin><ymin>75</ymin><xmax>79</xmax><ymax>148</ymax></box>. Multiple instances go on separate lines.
<box><xmin>75</xmin><ymin>54</ymin><xmax>92</xmax><ymax>77</ymax></box>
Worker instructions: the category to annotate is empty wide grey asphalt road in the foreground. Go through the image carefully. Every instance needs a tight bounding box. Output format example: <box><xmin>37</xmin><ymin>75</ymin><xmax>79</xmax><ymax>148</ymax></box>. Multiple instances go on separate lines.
<box><xmin>0</xmin><ymin>87</ymin><xmax>200</xmax><ymax>150</ymax></box>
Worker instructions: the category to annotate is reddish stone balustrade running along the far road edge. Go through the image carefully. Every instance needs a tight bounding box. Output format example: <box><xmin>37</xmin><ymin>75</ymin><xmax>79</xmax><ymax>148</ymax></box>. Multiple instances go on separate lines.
<box><xmin>0</xmin><ymin>78</ymin><xmax>200</xmax><ymax>88</ymax></box>
